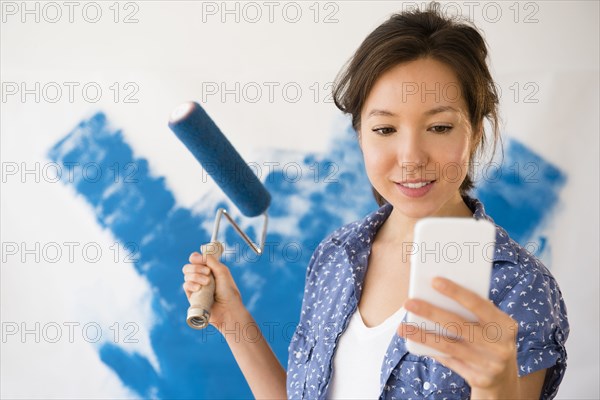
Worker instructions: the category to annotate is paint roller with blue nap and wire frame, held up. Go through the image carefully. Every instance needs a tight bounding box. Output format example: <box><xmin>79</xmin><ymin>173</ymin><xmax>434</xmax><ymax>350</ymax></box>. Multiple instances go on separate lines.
<box><xmin>169</xmin><ymin>102</ymin><xmax>271</xmax><ymax>329</ymax></box>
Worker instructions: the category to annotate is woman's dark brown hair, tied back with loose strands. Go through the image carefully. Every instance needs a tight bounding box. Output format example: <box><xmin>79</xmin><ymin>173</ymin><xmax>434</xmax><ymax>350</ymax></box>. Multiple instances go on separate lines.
<box><xmin>333</xmin><ymin>2</ymin><xmax>500</xmax><ymax>205</ymax></box>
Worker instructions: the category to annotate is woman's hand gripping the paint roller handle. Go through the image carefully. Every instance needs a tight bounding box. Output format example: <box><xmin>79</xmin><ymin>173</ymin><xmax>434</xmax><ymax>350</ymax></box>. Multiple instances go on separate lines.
<box><xmin>182</xmin><ymin>252</ymin><xmax>244</xmax><ymax>330</ymax></box>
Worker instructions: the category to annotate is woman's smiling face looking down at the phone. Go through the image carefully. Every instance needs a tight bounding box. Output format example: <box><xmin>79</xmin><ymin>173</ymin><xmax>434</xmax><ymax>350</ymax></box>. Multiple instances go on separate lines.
<box><xmin>359</xmin><ymin>58</ymin><xmax>472</xmax><ymax>218</ymax></box>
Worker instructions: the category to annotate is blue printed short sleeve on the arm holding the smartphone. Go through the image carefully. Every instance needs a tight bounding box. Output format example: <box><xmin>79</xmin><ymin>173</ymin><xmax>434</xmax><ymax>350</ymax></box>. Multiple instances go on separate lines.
<box><xmin>499</xmin><ymin>255</ymin><xmax>569</xmax><ymax>399</ymax></box>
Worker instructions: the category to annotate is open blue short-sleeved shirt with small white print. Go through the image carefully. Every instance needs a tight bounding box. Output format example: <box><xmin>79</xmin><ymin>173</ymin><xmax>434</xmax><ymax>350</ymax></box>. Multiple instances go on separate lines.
<box><xmin>287</xmin><ymin>197</ymin><xmax>569</xmax><ymax>400</ymax></box>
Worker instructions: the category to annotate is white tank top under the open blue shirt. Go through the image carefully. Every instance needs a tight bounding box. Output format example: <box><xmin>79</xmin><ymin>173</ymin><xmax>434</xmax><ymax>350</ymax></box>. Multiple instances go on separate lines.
<box><xmin>327</xmin><ymin>307</ymin><xmax>406</xmax><ymax>400</ymax></box>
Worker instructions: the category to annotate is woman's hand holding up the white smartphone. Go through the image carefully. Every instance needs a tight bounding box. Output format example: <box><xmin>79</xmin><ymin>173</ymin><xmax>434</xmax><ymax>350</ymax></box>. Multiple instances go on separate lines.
<box><xmin>398</xmin><ymin>277</ymin><xmax>519</xmax><ymax>398</ymax></box>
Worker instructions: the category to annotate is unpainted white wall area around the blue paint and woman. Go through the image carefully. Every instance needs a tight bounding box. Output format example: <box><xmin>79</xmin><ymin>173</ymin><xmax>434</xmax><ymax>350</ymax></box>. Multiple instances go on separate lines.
<box><xmin>0</xmin><ymin>1</ymin><xmax>600</xmax><ymax>399</ymax></box>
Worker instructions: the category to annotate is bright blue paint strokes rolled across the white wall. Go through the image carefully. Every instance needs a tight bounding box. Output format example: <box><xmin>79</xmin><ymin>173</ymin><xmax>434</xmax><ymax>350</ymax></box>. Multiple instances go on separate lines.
<box><xmin>49</xmin><ymin>113</ymin><xmax>565</xmax><ymax>399</ymax></box>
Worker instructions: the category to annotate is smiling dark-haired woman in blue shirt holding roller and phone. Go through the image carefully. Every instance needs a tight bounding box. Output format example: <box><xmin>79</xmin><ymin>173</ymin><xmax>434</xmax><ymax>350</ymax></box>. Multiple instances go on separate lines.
<box><xmin>183</xmin><ymin>4</ymin><xmax>569</xmax><ymax>399</ymax></box>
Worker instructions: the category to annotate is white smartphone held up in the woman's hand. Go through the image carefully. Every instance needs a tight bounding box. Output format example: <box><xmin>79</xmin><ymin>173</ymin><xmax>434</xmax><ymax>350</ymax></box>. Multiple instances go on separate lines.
<box><xmin>406</xmin><ymin>217</ymin><xmax>496</xmax><ymax>356</ymax></box>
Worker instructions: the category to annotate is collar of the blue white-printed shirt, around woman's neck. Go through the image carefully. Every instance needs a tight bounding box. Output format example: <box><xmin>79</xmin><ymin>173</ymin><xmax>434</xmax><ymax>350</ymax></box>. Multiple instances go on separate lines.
<box><xmin>334</xmin><ymin>196</ymin><xmax>518</xmax><ymax>266</ymax></box>
